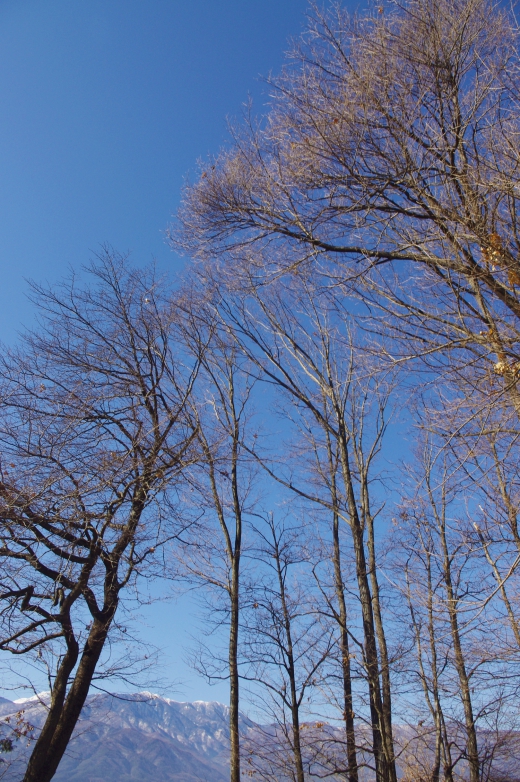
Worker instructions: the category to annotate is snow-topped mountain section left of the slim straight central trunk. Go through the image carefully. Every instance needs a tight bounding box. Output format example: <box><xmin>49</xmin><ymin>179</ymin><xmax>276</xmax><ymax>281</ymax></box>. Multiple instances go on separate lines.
<box><xmin>0</xmin><ymin>692</ymin><xmax>254</xmax><ymax>782</ymax></box>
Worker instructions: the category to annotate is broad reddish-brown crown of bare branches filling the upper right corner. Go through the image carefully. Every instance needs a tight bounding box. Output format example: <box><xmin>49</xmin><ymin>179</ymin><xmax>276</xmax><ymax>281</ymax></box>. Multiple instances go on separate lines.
<box><xmin>176</xmin><ymin>0</ymin><xmax>520</xmax><ymax>412</ymax></box>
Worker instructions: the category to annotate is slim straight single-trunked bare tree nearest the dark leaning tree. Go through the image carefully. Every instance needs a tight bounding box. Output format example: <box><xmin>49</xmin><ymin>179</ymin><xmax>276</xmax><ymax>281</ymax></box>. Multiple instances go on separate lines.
<box><xmin>173</xmin><ymin>287</ymin><xmax>259</xmax><ymax>782</ymax></box>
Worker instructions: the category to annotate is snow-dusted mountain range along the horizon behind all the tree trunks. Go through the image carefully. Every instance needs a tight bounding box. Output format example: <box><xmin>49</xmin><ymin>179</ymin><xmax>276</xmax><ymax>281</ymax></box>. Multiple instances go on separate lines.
<box><xmin>0</xmin><ymin>692</ymin><xmax>520</xmax><ymax>782</ymax></box>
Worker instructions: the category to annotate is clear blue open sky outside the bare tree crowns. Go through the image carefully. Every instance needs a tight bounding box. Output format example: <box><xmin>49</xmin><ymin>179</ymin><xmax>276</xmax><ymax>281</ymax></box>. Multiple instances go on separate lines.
<box><xmin>0</xmin><ymin>0</ymin><xmax>324</xmax><ymax>701</ymax></box>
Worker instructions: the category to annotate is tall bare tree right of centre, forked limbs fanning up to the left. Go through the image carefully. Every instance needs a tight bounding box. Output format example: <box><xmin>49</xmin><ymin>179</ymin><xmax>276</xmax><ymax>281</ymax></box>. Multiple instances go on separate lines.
<box><xmin>198</xmin><ymin>270</ymin><xmax>395</xmax><ymax>780</ymax></box>
